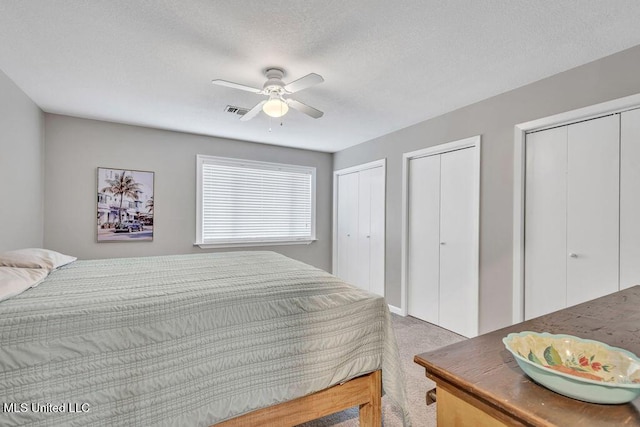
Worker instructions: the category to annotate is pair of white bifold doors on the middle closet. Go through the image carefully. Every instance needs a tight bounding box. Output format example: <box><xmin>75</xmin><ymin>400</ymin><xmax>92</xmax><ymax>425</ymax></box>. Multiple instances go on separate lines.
<box><xmin>407</xmin><ymin>148</ymin><xmax>478</xmax><ymax>337</ymax></box>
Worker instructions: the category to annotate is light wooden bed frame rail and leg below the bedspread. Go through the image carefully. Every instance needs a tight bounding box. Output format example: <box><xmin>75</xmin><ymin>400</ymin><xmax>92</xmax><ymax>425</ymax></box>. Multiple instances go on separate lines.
<box><xmin>216</xmin><ymin>370</ymin><xmax>382</xmax><ymax>427</ymax></box>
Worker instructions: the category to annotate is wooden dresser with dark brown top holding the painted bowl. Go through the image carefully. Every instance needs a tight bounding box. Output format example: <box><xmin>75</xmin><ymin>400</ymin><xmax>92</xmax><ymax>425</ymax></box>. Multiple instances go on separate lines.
<box><xmin>414</xmin><ymin>286</ymin><xmax>640</xmax><ymax>427</ymax></box>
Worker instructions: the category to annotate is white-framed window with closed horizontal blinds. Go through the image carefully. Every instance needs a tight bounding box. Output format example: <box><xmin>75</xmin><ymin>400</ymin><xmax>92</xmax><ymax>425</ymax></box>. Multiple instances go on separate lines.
<box><xmin>196</xmin><ymin>155</ymin><xmax>316</xmax><ymax>247</ymax></box>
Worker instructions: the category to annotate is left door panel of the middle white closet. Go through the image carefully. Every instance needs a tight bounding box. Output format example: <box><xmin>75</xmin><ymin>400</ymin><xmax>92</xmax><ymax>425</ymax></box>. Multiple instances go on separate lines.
<box><xmin>407</xmin><ymin>156</ymin><xmax>440</xmax><ymax>325</ymax></box>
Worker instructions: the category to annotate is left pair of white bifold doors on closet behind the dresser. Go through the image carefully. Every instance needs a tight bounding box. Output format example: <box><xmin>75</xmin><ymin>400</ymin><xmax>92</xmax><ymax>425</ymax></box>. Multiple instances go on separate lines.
<box><xmin>525</xmin><ymin>115</ymin><xmax>620</xmax><ymax>319</ymax></box>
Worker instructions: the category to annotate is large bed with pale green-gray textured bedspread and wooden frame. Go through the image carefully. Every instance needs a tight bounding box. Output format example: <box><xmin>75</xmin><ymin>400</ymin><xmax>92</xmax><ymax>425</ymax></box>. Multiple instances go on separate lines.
<box><xmin>0</xmin><ymin>252</ymin><xmax>408</xmax><ymax>426</ymax></box>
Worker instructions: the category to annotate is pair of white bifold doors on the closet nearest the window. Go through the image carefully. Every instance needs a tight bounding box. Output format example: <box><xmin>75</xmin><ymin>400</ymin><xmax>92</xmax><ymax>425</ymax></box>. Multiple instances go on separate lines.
<box><xmin>335</xmin><ymin>166</ymin><xmax>385</xmax><ymax>296</ymax></box>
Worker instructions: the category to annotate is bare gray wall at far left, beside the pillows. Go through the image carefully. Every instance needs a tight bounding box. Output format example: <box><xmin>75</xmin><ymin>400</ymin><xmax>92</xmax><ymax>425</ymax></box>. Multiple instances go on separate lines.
<box><xmin>0</xmin><ymin>71</ymin><xmax>44</xmax><ymax>251</ymax></box>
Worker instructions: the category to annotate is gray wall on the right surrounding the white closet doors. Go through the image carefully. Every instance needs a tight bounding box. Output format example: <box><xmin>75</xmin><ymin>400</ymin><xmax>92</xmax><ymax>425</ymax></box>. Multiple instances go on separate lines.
<box><xmin>334</xmin><ymin>46</ymin><xmax>640</xmax><ymax>332</ymax></box>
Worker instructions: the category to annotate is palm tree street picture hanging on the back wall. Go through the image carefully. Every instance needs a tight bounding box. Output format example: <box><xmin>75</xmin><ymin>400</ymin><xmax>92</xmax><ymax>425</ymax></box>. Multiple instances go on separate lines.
<box><xmin>97</xmin><ymin>167</ymin><xmax>154</xmax><ymax>242</ymax></box>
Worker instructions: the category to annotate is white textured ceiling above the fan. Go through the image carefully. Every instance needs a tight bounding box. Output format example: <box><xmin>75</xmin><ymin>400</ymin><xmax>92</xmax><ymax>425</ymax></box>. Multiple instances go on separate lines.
<box><xmin>0</xmin><ymin>0</ymin><xmax>640</xmax><ymax>152</ymax></box>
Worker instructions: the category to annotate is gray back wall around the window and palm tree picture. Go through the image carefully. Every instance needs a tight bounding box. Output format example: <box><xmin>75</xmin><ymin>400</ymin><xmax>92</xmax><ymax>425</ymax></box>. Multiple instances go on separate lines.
<box><xmin>44</xmin><ymin>114</ymin><xmax>332</xmax><ymax>271</ymax></box>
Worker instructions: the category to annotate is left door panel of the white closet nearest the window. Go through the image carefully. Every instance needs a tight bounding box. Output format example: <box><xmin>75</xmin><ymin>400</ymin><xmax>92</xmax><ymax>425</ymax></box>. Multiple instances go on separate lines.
<box><xmin>336</xmin><ymin>172</ymin><xmax>359</xmax><ymax>284</ymax></box>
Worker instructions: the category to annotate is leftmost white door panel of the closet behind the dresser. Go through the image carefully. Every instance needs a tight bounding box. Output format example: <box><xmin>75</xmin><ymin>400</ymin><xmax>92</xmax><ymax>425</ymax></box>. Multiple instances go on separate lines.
<box><xmin>524</xmin><ymin>126</ymin><xmax>567</xmax><ymax>320</ymax></box>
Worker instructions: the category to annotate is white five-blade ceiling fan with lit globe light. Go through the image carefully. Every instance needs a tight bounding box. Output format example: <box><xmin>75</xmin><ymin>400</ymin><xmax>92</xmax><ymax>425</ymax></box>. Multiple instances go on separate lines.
<box><xmin>211</xmin><ymin>68</ymin><xmax>324</xmax><ymax>121</ymax></box>
